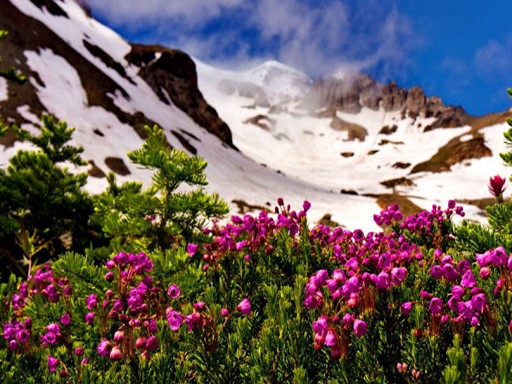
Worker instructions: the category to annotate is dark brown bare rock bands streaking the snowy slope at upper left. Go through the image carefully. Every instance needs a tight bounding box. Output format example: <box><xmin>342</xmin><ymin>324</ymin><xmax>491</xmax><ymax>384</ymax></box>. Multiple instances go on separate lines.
<box><xmin>0</xmin><ymin>0</ymin><xmax>155</xmax><ymax>145</ymax></box>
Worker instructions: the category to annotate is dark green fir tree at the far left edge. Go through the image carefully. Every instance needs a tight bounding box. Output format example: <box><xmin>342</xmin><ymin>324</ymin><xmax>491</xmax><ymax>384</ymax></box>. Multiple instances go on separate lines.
<box><xmin>0</xmin><ymin>116</ymin><xmax>92</xmax><ymax>273</ymax></box>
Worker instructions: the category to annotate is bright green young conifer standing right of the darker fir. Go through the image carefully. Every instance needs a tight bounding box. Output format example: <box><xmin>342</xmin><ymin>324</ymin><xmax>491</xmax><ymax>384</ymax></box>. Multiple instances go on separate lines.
<box><xmin>93</xmin><ymin>126</ymin><xmax>228</xmax><ymax>250</ymax></box>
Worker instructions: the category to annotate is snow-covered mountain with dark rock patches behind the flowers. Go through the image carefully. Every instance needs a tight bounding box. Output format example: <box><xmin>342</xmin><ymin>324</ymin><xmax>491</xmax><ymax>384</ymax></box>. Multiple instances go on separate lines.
<box><xmin>0</xmin><ymin>0</ymin><xmax>510</xmax><ymax>229</ymax></box>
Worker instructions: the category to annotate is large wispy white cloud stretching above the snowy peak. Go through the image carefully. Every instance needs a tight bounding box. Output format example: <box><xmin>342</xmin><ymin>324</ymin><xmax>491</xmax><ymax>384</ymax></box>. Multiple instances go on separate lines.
<box><xmin>83</xmin><ymin>0</ymin><xmax>415</xmax><ymax>76</ymax></box>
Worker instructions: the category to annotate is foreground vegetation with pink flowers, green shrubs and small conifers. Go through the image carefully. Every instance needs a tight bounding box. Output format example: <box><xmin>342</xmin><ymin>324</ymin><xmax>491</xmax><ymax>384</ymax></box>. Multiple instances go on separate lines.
<box><xmin>0</xmin><ymin>27</ymin><xmax>512</xmax><ymax>383</ymax></box>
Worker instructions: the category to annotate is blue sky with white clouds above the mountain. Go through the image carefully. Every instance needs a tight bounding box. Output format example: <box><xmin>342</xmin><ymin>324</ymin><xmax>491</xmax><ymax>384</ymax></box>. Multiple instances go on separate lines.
<box><xmin>80</xmin><ymin>0</ymin><xmax>512</xmax><ymax>115</ymax></box>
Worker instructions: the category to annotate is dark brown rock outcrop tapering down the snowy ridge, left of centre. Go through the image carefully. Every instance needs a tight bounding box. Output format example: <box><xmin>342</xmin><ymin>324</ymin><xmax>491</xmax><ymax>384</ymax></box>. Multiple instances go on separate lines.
<box><xmin>126</xmin><ymin>44</ymin><xmax>235</xmax><ymax>148</ymax></box>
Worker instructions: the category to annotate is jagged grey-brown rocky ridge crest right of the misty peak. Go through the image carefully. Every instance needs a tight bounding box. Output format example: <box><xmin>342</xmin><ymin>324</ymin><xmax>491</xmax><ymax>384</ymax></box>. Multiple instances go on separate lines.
<box><xmin>304</xmin><ymin>75</ymin><xmax>470</xmax><ymax>130</ymax></box>
